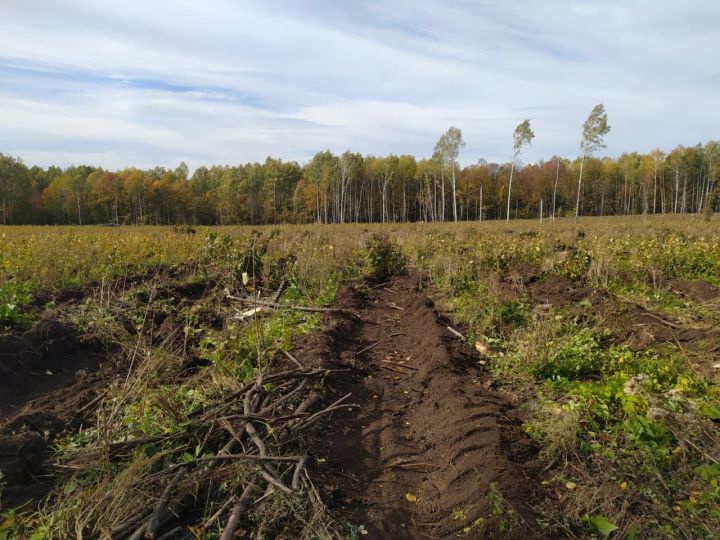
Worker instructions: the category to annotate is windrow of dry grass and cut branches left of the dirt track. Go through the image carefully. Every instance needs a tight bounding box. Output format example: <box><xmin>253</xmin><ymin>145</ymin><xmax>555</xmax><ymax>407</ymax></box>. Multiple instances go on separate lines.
<box><xmin>28</xmin><ymin>268</ymin><xmax>355</xmax><ymax>540</ymax></box>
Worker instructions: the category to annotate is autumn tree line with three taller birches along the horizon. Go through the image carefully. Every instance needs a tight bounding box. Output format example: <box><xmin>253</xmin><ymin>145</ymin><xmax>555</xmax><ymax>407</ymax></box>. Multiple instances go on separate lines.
<box><xmin>0</xmin><ymin>115</ymin><xmax>720</xmax><ymax>225</ymax></box>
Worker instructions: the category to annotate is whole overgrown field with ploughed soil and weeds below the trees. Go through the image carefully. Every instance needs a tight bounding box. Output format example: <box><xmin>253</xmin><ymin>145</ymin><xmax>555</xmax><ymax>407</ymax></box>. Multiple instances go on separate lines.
<box><xmin>0</xmin><ymin>215</ymin><xmax>720</xmax><ymax>540</ymax></box>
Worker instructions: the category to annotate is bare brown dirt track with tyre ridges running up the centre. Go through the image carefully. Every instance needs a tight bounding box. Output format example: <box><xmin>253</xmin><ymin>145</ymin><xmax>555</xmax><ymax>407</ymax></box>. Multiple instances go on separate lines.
<box><xmin>298</xmin><ymin>277</ymin><xmax>538</xmax><ymax>538</ymax></box>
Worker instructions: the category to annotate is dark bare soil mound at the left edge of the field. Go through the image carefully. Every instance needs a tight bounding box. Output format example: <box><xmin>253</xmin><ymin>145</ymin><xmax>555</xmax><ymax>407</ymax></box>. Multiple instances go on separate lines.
<box><xmin>0</xmin><ymin>318</ymin><xmax>106</xmax><ymax>508</ymax></box>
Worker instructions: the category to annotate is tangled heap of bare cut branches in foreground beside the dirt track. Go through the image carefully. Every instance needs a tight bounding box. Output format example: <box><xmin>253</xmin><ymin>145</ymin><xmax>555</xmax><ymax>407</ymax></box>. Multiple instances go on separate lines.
<box><xmin>111</xmin><ymin>362</ymin><xmax>357</xmax><ymax>540</ymax></box>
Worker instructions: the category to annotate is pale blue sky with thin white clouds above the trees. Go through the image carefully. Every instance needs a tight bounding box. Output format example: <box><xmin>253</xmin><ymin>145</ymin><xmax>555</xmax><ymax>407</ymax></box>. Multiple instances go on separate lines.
<box><xmin>0</xmin><ymin>0</ymin><xmax>720</xmax><ymax>168</ymax></box>
